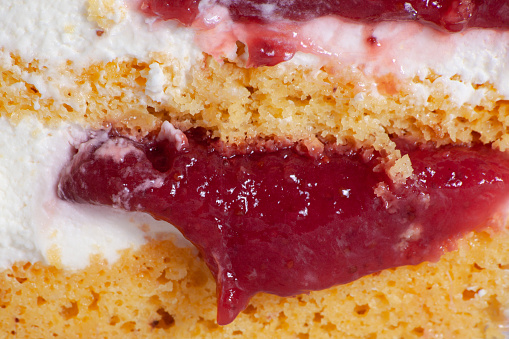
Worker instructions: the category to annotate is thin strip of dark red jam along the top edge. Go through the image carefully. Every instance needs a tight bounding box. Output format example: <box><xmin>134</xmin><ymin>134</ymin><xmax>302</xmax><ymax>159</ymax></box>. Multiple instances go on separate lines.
<box><xmin>142</xmin><ymin>0</ymin><xmax>509</xmax><ymax>32</ymax></box>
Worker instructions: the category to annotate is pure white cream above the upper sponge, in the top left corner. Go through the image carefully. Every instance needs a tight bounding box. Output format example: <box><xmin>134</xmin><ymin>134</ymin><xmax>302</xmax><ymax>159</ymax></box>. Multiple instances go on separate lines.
<box><xmin>0</xmin><ymin>0</ymin><xmax>201</xmax><ymax>67</ymax></box>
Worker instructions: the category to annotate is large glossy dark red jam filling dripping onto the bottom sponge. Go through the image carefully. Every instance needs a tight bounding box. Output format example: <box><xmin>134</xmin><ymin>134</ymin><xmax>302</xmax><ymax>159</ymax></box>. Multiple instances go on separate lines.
<box><xmin>58</xmin><ymin>124</ymin><xmax>509</xmax><ymax>324</ymax></box>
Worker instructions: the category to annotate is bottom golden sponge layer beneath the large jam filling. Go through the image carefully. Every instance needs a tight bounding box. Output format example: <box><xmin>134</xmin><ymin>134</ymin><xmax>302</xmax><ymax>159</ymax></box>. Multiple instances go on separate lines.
<box><xmin>0</xmin><ymin>232</ymin><xmax>509</xmax><ymax>338</ymax></box>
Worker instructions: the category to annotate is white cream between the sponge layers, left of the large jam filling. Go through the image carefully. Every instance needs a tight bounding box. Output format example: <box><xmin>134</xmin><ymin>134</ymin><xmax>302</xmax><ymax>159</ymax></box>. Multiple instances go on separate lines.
<box><xmin>0</xmin><ymin>118</ymin><xmax>190</xmax><ymax>269</ymax></box>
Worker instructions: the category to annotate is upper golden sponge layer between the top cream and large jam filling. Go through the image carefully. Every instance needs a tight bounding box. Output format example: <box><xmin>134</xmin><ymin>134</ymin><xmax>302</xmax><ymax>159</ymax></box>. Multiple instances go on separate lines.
<box><xmin>0</xmin><ymin>53</ymin><xmax>509</xmax><ymax>158</ymax></box>
